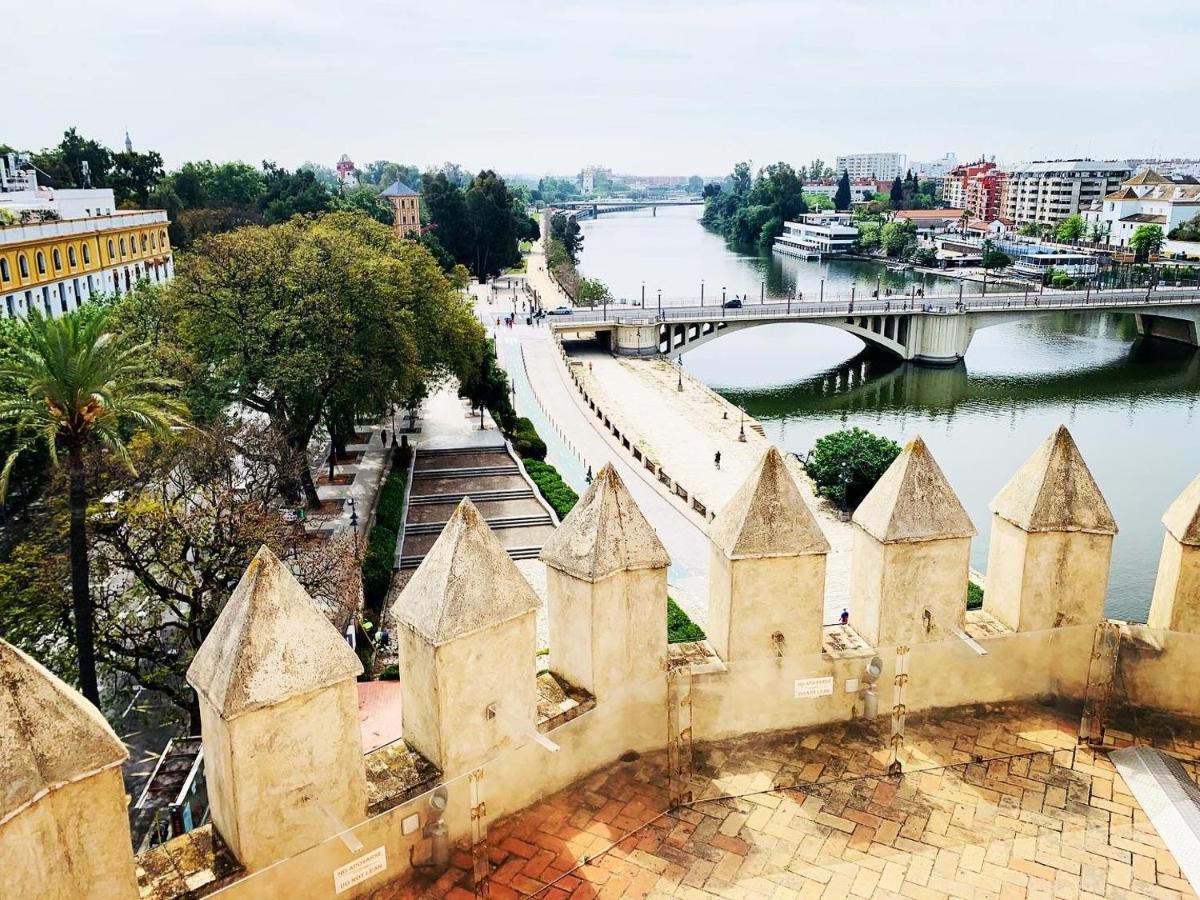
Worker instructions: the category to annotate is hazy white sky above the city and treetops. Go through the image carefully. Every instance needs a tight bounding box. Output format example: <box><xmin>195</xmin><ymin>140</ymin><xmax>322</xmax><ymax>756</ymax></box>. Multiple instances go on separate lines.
<box><xmin>11</xmin><ymin>0</ymin><xmax>1200</xmax><ymax>175</ymax></box>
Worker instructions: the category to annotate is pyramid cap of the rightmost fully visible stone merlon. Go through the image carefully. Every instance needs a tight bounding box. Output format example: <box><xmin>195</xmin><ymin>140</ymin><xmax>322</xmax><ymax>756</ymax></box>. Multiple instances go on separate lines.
<box><xmin>991</xmin><ymin>425</ymin><xmax>1117</xmax><ymax>534</ymax></box>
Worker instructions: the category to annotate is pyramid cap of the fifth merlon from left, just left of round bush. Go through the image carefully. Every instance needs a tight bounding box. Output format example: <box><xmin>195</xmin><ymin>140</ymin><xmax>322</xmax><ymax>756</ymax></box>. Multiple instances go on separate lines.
<box><xmin>708</xmin><ymin>446</ymin><xmax>829</xmax><ymax>559</ymax></box>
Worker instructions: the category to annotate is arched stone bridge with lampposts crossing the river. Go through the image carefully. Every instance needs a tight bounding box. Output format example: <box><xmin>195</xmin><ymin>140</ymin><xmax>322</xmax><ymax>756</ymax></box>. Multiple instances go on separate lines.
<box><xmin>551</xmin><ymin>287</ymin><xmax>1200</xmax><ymax>365</ymax></box>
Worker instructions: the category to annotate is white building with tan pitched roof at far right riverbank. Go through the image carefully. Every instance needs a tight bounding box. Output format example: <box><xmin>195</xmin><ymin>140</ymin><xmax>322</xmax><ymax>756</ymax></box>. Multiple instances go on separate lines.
<box><xmin>1084</xmin><ymin>169</ymin><xmax>1200</xmax><ymax>247</ymax></box>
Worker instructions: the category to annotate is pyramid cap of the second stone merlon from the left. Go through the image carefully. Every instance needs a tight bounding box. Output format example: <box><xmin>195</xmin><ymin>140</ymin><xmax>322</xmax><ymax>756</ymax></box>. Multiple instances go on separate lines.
<box><xmin>187</xmin><ymin>546</ymin><xmax>362</xmax><ymax>719</ymax></box>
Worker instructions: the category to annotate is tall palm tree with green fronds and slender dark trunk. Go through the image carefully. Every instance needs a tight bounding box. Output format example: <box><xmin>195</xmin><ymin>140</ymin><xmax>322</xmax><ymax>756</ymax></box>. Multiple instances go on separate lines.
<box><xmin>0</xmin><ymin>310</ymin><xmax>185</xmax><ymax>707</ymax></box>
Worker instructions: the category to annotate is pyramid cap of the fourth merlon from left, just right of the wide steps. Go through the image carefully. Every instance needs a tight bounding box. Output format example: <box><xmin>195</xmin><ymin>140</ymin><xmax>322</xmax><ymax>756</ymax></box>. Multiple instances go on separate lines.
<box><xmin>540</xmin><ymin>466</ymin><xmax>671</xmax><ymax>582</ymax></box>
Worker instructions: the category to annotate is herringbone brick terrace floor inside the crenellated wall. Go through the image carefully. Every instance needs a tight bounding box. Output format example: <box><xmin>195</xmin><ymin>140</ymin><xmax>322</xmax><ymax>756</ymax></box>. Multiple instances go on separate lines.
<box><xmin>374</xmin><ymin>704</ymin><xmax>1200</xmax><ymax>900</ymax></box>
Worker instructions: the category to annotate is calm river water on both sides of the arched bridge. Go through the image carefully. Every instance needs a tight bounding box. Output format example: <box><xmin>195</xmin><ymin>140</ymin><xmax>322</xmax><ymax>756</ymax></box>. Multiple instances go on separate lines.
<box><xmin>580</xmin><ymin>206</ymin><xmax>1200</xmax><ymax>622</ymax></box>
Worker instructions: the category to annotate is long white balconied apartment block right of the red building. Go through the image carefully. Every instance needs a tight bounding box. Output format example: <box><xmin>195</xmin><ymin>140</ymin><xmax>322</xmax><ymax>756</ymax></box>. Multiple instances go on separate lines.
<box><xmin>1001</xmin><ymin>160</ymin><xmax>1130</xmax><ymax>227</ymax></box>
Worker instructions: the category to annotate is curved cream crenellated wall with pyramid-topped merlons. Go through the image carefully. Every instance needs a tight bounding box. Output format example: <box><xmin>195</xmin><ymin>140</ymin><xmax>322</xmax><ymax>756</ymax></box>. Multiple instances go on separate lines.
<box><xmin>0</xmin><ymin>428</ymin><xmax>1200</xmax><ymax>900</ymax></box>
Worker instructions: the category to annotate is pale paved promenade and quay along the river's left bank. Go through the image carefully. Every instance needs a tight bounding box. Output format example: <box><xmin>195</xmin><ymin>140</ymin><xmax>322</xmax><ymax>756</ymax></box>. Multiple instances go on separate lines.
<box><xmin>474</xmin><ymin>241</ymin><xmax>853</xmax><ymax>625</ymax></box>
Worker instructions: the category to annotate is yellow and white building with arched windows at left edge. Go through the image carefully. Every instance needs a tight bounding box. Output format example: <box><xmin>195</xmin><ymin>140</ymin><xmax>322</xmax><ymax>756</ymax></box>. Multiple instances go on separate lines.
<box><xmin>0</xmin><ymin>157</ymin><xmax>175</xmax><ymax>318</ymax></box>
